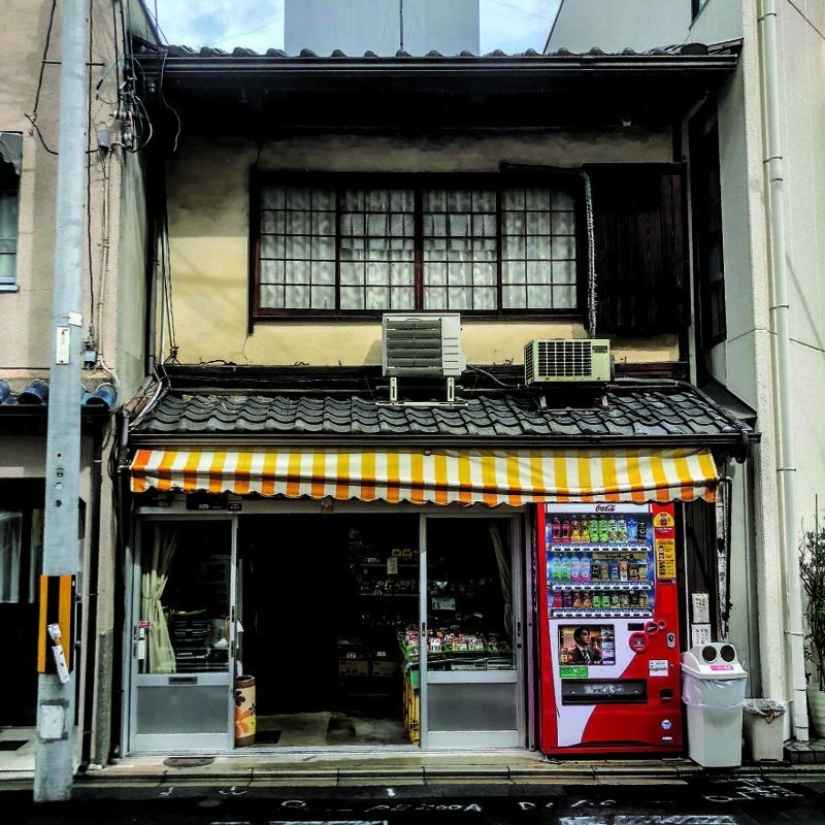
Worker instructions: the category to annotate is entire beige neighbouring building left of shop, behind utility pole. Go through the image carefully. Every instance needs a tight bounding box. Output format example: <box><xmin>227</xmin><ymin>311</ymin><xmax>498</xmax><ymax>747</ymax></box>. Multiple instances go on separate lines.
<box><xmin>0</xmin><ymin>0</ymin><xmax>156</xmax><ymax>761</ymax></box>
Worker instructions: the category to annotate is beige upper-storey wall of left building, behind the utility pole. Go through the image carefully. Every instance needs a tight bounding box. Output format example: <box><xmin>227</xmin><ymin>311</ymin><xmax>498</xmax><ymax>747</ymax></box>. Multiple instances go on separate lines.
<box><xmin>0</xmin><ymin>0</ymin><xmax>144</xmax><ymax>391</ymax></box>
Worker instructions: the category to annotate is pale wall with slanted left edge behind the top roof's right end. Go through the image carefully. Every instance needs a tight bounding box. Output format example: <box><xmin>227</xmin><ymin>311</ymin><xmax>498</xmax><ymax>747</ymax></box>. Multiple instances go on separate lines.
<box><xmin>544</xmin><ymin>0</ymin><xmax>690</xmax><ymax>53</ymax></box>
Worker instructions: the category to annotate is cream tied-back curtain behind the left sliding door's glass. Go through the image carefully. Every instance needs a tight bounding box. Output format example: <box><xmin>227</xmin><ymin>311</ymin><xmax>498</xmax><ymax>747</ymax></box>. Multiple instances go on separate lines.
<box><xmin>140</xmin><ymin>528</ymin><xmax>178</xmax><ymax>673</ymax></box>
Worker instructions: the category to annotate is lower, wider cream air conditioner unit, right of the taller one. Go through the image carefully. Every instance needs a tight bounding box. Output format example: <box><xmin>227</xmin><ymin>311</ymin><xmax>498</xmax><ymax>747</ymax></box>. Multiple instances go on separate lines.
<box><xmin>524</xmin><ymin>338</ymin><xmax>613</xmax><ymax>384</ymax></box>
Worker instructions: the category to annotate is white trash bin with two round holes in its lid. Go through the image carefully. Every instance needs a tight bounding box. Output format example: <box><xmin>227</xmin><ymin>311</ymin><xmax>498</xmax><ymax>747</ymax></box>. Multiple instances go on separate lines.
<box><xmin>682</xmin><ymin>642</ymin><xmax>748</xmax><ymax>768</ymax></box>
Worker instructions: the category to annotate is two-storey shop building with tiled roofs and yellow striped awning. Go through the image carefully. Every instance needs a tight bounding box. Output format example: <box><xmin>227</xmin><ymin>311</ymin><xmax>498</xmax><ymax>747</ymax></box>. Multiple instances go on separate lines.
<box><xmin>113</xmin><ymin>14</ymin><xmax>759</xmax><ymax>756</ymax></box>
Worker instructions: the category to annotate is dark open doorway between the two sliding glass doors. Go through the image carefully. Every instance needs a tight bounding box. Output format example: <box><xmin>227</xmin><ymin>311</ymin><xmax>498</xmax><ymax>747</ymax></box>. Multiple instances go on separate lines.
<box><xmin>238</xmin><ymin>515</ymin><xmax>420</xmax><ymax>747</ymax></box>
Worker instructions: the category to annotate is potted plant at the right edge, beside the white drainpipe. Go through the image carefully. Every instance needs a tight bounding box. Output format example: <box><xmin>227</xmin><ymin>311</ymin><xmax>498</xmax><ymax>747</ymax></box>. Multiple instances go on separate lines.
<box><xmin>799</xmin><ymin>526</ymin><xmax>825</xmax><ymax>736</ymax></box>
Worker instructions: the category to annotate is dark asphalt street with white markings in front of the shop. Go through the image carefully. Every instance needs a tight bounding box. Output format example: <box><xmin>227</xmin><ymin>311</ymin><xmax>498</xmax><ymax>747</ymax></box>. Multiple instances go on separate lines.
<box><xmin>0</xmin><ymin>775</ymin><xmax>825</xmax><ymax>825</ymax></box>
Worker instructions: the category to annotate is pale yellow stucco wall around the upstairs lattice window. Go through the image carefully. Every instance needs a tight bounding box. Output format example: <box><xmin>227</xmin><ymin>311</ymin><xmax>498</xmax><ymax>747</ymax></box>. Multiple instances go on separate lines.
<box><xmin>164</xmin><ymin>133</ymin><xmax>678</xmax><ymax>366</ymax></box>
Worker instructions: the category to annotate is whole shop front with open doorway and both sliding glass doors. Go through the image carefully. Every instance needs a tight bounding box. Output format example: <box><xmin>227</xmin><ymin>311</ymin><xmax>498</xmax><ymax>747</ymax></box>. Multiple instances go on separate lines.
<box><xmin>128</xmin><ymin>511</ymin><xmax>525</xmax><ymax>751</ymax></box>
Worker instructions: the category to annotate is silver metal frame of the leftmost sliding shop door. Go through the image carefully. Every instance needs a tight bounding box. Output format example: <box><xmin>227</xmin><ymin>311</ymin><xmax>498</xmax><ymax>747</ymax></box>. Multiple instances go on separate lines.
<box><xmin>123</xmin><ymin>510</ymin><xmax>238</xmax><ymax>753</ymax></box>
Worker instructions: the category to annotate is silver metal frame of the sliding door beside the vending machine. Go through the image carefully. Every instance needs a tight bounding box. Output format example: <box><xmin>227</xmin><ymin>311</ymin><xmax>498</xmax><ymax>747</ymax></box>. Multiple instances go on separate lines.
<box><xmin>418</xmin><ymin>512</ymin><xmax>528</xmax><ymax>751</ymax></box>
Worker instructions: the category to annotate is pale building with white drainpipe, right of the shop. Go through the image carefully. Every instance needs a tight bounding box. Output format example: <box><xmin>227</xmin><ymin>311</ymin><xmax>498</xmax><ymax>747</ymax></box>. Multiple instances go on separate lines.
<box><xmin>547</xmin><ymin>0</ymin><xmax>825</xmax><ymax>740</ymax></box>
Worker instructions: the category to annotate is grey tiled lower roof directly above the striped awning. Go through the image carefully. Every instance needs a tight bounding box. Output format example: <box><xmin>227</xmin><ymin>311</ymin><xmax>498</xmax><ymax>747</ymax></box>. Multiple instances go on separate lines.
<box><xmin>132</xmin><ymin>382</ymin><xmax>755</xmax><ymax>445</ymax></box>
